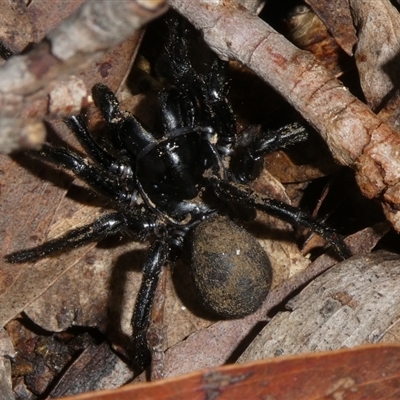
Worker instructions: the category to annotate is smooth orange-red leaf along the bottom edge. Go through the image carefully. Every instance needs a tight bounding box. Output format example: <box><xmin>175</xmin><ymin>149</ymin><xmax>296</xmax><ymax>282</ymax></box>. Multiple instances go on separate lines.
<box><xmin>57</xmin><ymin>345</ymin><xmax>400</xmax><ymax>400</ymax></box>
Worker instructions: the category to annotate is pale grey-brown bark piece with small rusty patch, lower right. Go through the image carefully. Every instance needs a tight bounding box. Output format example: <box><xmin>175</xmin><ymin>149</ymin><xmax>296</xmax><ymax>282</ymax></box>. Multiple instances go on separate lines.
<box><xmin>238</xmin><ymin>251</ymin><xmax>400</xmax><ymax>362</ymax></box>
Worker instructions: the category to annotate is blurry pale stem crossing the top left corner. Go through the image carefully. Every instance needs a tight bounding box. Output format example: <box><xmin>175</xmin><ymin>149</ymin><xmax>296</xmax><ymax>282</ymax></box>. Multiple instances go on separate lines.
<box><xmin>0</xmin><ymin>0</ymin><xmax>167</xmax><ymax>153</ymax></box>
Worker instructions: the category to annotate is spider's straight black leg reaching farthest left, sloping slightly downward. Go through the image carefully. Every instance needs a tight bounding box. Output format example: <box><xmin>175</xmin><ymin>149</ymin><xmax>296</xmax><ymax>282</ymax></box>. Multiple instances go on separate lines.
<box><xmin>6</xmin><ymin>213</ymin><xmax>128</xmax><ymax>263</ymax></box>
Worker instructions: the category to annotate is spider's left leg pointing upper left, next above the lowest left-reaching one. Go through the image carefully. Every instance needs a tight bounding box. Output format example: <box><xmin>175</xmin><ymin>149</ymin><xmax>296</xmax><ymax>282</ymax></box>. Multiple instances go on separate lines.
<box><xmin>29</xmin><ymin>144</ymin><xmax>130</xmax><ymax>202</ymax></box>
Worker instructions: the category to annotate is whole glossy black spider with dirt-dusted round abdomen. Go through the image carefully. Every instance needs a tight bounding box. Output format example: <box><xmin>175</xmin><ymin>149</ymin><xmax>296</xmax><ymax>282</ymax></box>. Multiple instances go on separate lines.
<box><xmin>7</xmin><ymin>16</ymin><xmax>349</xmax><ymax>369</ymax></box>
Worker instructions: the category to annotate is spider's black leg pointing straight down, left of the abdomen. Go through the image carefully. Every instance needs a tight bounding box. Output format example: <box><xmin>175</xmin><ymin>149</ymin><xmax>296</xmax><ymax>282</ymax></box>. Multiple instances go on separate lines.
<box><xmin>131</xmin><ymin>240</ymin><xmax>169</xmax><ymax>371</ymax></box>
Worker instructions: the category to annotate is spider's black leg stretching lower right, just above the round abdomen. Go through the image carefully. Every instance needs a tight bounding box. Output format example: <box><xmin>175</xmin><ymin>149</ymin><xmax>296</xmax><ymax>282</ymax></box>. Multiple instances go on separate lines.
<box><xmin>206</xmin><ymin>176</ymin><xmax>351</xmax><ymax>259</ymax></box>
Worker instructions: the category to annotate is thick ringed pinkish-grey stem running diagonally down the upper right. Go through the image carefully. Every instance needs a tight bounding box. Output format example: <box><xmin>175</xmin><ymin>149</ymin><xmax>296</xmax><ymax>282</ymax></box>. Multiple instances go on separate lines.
<box><xmin>170</xmin><ymin>0</ymin><xmax>400</xmax><ymax>231</ymax></box>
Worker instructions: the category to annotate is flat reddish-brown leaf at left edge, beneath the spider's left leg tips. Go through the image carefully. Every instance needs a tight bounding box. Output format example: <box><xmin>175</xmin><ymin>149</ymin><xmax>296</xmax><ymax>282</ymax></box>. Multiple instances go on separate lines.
<box><xmin>0</xmin><ymin>152</ymin><xmax>70</xmax><ymax>325</ymax></box>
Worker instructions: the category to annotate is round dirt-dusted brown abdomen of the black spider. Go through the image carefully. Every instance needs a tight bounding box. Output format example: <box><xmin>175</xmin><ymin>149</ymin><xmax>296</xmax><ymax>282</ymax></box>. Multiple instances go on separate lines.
<box><xmin>192</xmin><ymin>216</ymin><xmax>272</xmax><ymax>318</ymax></box>
